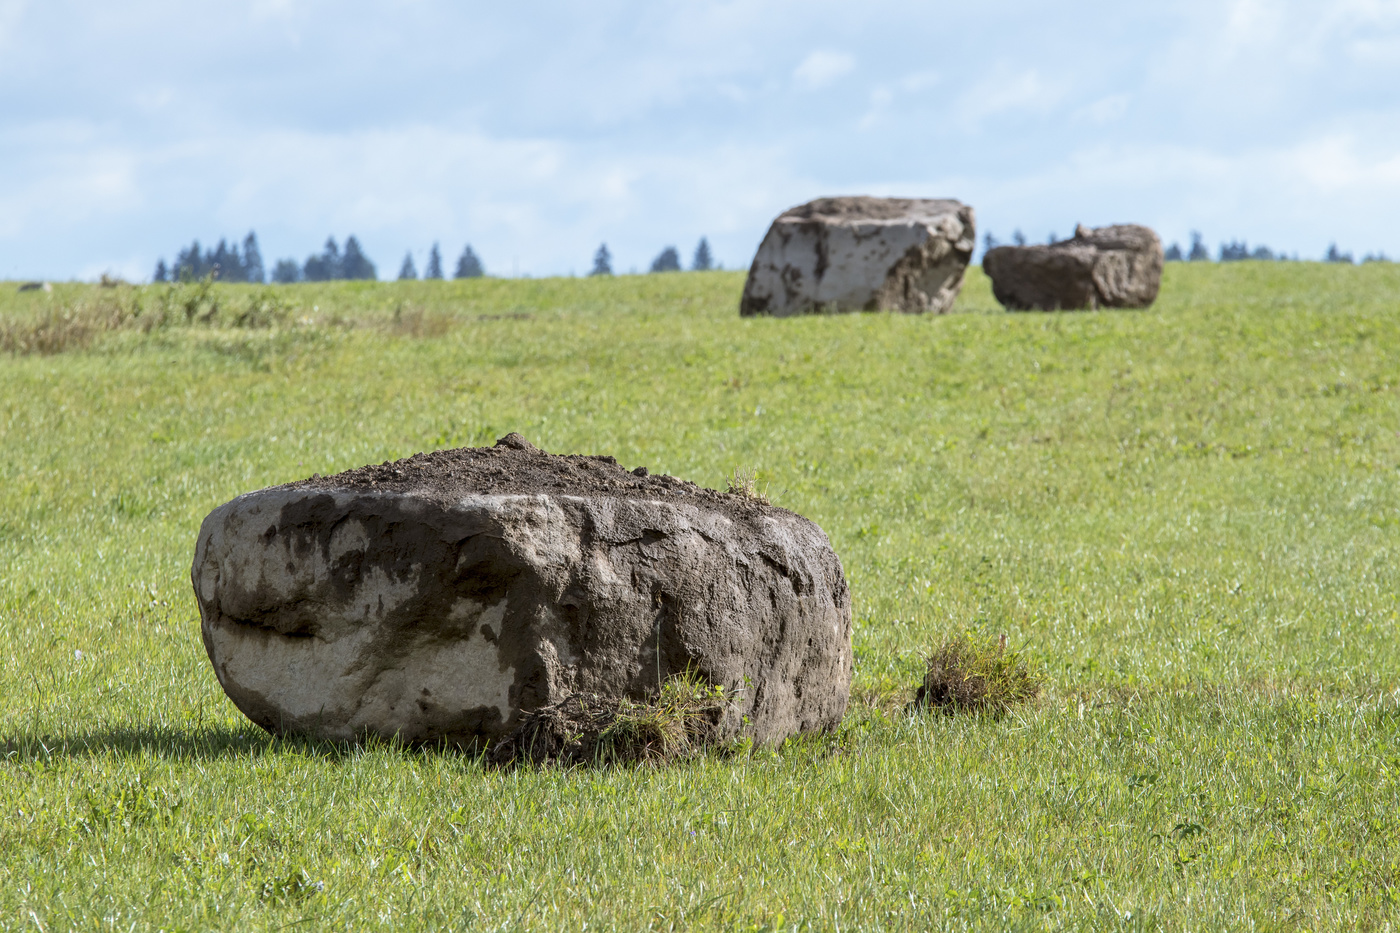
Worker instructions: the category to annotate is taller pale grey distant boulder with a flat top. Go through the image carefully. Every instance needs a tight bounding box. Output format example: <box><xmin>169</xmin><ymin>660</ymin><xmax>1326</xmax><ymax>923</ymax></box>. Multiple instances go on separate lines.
<box><xmin>739</xmin><ymin>198</ymin><xmax>977</xmax><ymax>317</ymax></box>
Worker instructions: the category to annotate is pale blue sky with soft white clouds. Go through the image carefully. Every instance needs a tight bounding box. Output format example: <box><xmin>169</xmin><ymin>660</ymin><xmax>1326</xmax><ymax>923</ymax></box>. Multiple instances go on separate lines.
<box><xmin>0</xmin><ymin>0</ymin><xmax>1400</xmax><ymax>280</ymax></box>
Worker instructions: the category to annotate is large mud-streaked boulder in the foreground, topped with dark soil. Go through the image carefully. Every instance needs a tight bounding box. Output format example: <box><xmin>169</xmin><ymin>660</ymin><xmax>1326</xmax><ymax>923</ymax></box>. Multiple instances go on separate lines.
<box><xmin>192</xmin><ymin>434</ymin><xmax>851</xmax><ymax>745</ymax></box>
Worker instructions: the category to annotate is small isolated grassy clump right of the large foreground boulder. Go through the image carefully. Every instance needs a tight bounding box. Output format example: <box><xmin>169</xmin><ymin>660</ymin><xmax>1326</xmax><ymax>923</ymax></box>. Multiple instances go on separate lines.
<box><xmin>910</xmin><ymin>635</ymin><xmax>1042</xmax><ymax>716</ymax></box>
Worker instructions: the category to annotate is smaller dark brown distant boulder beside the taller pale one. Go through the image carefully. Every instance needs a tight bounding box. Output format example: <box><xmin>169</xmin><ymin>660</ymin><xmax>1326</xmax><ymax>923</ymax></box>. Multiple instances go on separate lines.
<box><xmin>981</xmin><ymin>224</ymin><xmax>1162</xmax><ymax>311</ymax></box>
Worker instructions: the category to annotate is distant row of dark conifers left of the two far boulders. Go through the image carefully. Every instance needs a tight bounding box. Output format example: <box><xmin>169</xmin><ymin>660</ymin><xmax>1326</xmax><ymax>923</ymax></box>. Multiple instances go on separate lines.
<box><xmin>151</xmin><ymin>231</ymin><xmax>722</xmax><ymax>284</ymax></box>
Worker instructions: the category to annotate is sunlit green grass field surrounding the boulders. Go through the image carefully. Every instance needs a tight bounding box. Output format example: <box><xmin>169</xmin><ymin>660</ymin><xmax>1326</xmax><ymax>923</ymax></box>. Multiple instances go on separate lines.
<box><xmin>0</xmin><ymin>262</ymin><xmax>1400</xmax><ymax>930</ymax></box>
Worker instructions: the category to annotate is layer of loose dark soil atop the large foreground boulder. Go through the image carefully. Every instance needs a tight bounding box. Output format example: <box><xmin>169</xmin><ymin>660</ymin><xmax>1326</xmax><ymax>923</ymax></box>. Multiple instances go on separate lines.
<box><xmin>287</xmin><ymin>431</ymin><xmax>787</xmax><ymax>518</ymax></box>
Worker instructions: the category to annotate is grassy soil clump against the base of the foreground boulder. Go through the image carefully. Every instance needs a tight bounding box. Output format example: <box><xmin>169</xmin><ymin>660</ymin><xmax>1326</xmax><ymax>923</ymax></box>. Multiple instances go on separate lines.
<box><xmin>486</xmin><ymin>677</ymin><xmax>729</xmax><ymax>768</ymax></box>
